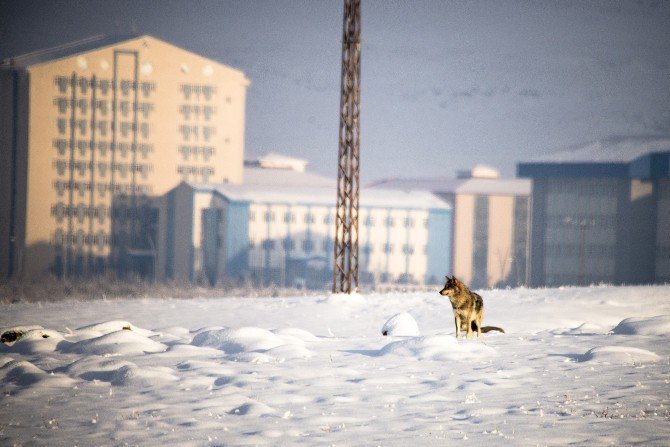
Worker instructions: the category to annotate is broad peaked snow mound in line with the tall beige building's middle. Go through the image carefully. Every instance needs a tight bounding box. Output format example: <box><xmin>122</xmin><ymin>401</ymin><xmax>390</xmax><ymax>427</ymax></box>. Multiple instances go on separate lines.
<box><xmin>64</xmin><ymin>329</ymin><xmax>167</xmax><ymax>355</ymax></box>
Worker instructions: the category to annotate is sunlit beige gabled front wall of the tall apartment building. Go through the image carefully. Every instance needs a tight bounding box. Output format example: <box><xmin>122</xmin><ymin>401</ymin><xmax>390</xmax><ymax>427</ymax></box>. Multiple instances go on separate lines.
<box><xmin>3</xmin><ymin>36</ymin><xmax>248</xmax><ymax>275</ymax></box>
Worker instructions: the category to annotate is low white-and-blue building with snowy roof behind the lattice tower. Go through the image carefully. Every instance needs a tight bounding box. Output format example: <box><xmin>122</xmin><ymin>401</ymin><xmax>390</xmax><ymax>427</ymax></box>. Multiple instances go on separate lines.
<box><xmin>161</xmin><ymin>157</ymin><xmax>452</xmax><ymax>288</ymax></box>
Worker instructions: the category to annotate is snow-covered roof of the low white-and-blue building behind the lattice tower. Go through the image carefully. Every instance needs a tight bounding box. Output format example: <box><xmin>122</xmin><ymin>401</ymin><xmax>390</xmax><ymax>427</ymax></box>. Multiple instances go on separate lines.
<box><xmin>191</xmin><ymin>184</ymin><xmax>451</xmax><ymax>210</ymax></box>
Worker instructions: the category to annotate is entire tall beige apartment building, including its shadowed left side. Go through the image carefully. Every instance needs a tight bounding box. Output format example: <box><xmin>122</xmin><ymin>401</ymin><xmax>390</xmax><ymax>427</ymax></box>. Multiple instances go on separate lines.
<box><xmin>0</xmin><ymin>35</ymin><xmax>249</xmax><ymax>280</ymax></box>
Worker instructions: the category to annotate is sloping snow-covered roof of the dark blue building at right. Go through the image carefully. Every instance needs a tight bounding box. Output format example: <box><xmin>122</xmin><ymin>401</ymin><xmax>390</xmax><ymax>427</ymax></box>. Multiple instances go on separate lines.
<box><xmin>529</xmin><ymin>136</ymin><xmax>670</xmax><ymax>163</ymax></box>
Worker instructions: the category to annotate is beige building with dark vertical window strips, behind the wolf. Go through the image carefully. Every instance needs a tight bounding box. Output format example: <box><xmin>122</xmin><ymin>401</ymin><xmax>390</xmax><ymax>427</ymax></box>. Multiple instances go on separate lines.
<box><xmin>373</xmin><ymin>166</ymin><xmax>531</xmax><ymax>288</ymax></box>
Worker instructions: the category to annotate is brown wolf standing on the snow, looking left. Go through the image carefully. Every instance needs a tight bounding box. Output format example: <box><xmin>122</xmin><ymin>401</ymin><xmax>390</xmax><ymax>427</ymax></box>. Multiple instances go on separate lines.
<box><xmin>440</xmin><ymin>276</ymin><xmax>505</xmax><ymax>338</ymax></box>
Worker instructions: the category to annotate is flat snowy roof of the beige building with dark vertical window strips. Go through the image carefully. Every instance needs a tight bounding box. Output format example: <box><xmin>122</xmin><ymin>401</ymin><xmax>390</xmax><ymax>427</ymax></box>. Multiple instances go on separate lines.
<box><xmin>372</xmin><ymin>178</ymin><xmax>531</xmax><ymax>196</ymax></box>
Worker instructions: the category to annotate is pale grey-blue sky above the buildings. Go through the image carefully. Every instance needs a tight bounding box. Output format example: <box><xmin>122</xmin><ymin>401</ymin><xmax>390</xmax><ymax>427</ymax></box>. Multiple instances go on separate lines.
<box><xmin>0</xmin><ymin>0</ymin><xmax>670</xmax><ymax>184</ymax></box>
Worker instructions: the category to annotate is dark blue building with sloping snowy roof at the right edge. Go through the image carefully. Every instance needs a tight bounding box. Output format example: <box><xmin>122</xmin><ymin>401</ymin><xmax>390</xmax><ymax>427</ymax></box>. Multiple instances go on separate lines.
<box><xmin>518</xmin><ymin>137</ymin><xmax>670</xmax><ymax>286</ymax></box>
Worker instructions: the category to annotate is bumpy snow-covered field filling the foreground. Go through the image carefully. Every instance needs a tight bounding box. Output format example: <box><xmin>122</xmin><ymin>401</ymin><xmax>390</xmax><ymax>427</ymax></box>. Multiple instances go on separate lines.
<box><xmin>0</xmin><ymin>286</ymin><xmax>670</xmax><ymax>446</ymax></box>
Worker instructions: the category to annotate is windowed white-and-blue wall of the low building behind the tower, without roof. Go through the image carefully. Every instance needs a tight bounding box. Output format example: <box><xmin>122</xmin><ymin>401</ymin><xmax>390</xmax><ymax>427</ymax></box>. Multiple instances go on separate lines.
<box><xmin>204</xmin><ymin>202</ymin><xmax>451</xmax><ymax>287</ymax></box>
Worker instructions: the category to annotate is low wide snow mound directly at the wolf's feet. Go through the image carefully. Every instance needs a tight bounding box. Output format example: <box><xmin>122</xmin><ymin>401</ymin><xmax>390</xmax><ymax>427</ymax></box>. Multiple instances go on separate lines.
<box><xmin>379</xmin><ymin>335</ymin><xmax>497</xmax><ymax>361</ymax></box>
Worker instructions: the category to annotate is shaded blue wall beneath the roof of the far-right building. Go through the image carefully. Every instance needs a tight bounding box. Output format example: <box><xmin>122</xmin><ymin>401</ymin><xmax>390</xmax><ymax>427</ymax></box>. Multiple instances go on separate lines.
<box><xmin>532</xmin><ymin>177</ymin><xmax>665</xmax><ymax>286</ymax></box>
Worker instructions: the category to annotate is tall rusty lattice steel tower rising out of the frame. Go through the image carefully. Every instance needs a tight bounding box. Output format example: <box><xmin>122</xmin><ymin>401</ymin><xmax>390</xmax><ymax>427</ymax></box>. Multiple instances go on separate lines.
<box><xmin>333</xmin><ymin>0</ymin><xmax>361</xmax><ymax>293</ymax></box>
